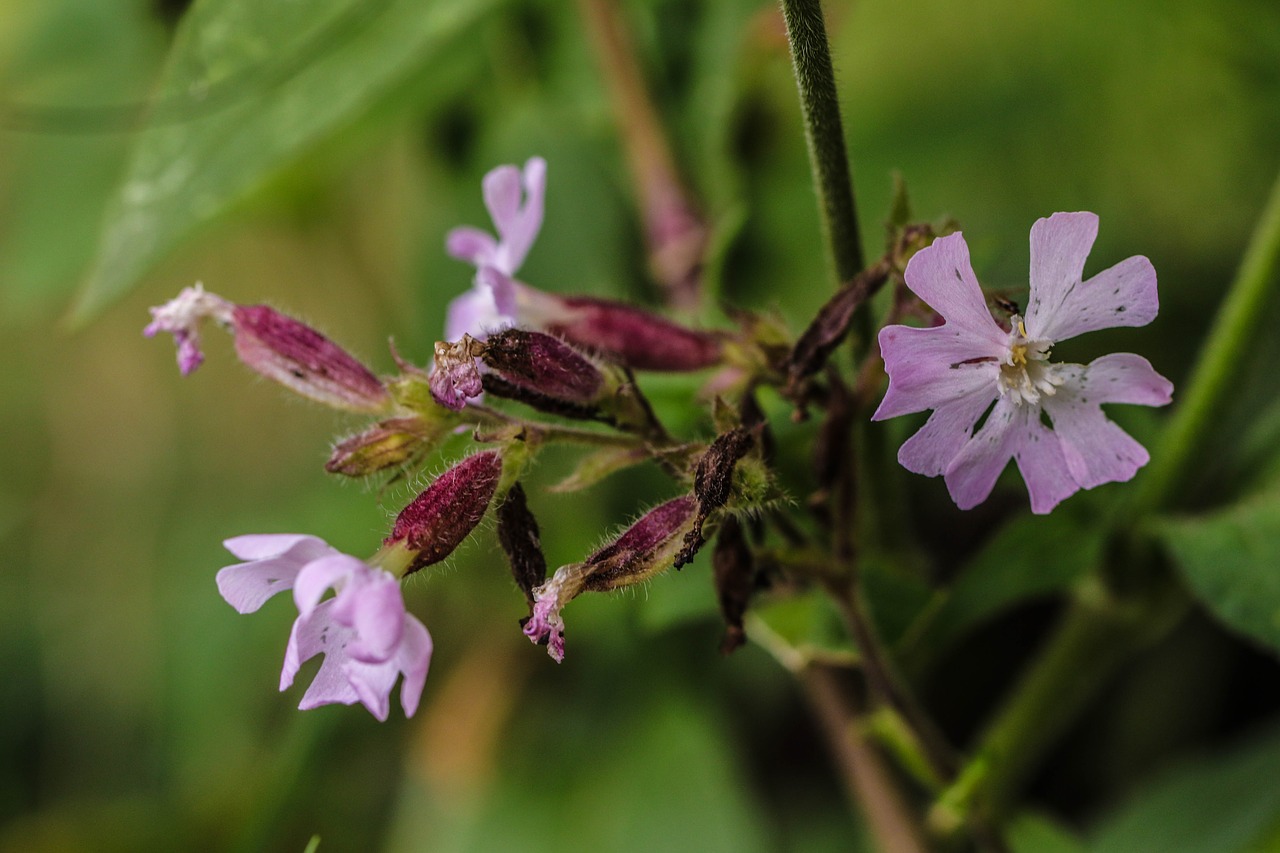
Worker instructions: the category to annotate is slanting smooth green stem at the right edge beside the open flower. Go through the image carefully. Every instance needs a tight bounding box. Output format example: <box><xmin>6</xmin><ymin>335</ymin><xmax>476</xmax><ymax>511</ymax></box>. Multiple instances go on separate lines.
<box><xmin>1125</xmin><ymin>166</ymin><xmax>1280</xmax><ymax>512</ymax></box>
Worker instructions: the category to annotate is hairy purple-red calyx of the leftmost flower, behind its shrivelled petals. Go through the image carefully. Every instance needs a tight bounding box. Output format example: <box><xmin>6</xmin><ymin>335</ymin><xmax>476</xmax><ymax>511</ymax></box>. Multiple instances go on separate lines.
<box><xmin>232</xmin><ymin>305</ymin><xmax>390</xmax><ymax>411</ymax></box>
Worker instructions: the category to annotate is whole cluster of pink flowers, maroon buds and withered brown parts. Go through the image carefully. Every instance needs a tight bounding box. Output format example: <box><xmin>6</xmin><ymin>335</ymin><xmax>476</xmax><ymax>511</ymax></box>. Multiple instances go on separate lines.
<box><xmin>145</xmin><ymin>158</ymin><xmax>1171</xmax><ymax>720</ymax></box>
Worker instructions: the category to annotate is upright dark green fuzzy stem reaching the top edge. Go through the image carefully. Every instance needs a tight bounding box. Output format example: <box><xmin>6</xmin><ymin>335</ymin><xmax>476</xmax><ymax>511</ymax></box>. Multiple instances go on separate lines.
<box><xmin>782</xmin><ymin>0</ymin><xmax>863</xmax><ymax>283</ymax></box>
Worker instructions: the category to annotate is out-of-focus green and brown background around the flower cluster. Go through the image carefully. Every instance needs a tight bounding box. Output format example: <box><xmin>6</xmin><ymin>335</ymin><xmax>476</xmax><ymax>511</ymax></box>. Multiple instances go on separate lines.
<box><xmin>0</xmin><ymin>0</ymin><xmax>1280</xmax><ymax>852</ymax></box>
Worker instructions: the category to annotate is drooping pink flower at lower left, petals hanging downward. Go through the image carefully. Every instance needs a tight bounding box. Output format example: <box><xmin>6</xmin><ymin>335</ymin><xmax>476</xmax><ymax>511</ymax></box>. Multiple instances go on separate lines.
<box><xmin>218</xmin><ymin>534</ymin><xmax>431</xmax><ymax>720</ymax></box>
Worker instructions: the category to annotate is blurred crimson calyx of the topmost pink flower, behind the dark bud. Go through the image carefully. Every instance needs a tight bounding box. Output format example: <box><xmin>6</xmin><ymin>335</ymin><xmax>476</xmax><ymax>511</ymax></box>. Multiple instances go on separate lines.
<box><xmin>545</xmin><ymin>296</ymin><xmax>723</xmax><ymax>371</ymax></box>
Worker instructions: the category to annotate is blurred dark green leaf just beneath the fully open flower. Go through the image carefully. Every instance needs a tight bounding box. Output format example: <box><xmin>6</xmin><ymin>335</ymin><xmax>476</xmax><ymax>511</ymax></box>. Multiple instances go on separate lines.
<box><xmin>915</xmin><ymin>511</ymin><xmax>1102</xmax><ymax>649</ymax></box>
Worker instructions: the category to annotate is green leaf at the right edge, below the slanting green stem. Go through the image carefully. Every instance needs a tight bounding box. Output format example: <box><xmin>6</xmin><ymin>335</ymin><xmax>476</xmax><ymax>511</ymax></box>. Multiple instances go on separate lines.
<box><xmin>1156</xmin><ymin>491</ymin><xmax>1280</xmax><ymax>651</ymax></box>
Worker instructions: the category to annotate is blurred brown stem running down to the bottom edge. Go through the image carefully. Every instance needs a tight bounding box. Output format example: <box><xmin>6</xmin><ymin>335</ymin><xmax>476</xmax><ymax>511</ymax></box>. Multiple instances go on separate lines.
<box><xmin>799</xmin><ymin>663</ymin><xmax>928</xmax><ymax>853</ymax></box>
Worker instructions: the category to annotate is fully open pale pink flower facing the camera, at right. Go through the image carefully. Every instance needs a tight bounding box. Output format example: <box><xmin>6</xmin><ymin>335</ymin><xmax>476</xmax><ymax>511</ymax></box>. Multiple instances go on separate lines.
<box><xmin>873</xmin><ymin>213</ymin><xmax>1172</xmax><ymax>514</ymax></box>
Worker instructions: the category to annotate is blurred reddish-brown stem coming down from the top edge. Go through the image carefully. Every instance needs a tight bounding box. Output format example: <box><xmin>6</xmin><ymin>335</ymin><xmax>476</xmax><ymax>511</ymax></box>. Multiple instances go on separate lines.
<box><xmin>577</xmin><ymin>0</ymin><xmax>709</xmax><ymax>310</ymax></box>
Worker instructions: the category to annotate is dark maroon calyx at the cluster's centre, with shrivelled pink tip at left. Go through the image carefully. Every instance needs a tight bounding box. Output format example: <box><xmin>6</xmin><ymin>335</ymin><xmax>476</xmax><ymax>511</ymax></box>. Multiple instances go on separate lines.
<box><xmin>480</xmin><ymin>329</ymin><xmax>604</xmax><ymax>405</ymax></box>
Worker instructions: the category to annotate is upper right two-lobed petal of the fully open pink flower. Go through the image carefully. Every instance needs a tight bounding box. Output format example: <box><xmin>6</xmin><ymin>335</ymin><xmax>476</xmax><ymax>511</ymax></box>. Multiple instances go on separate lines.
<box><xmin>1027</xmin><ymin>213</ymin><xmax>1160</xmax><ymax>341</ymax></box>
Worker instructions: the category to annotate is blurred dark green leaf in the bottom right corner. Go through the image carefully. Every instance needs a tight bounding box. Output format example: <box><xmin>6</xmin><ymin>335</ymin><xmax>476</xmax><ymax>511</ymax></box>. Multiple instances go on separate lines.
<box><xmin>1089</xmin><ymin>717</ymin><xmax>1280</xmax><ymax>853</ymax></box>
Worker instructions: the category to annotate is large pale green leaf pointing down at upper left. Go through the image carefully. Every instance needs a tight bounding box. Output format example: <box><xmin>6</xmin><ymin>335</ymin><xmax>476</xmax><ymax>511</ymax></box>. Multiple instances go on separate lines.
<box><xmin>72</xmin><ymin>0</ymin><xmax>495</xmax><ymax>323</ymax></box>
